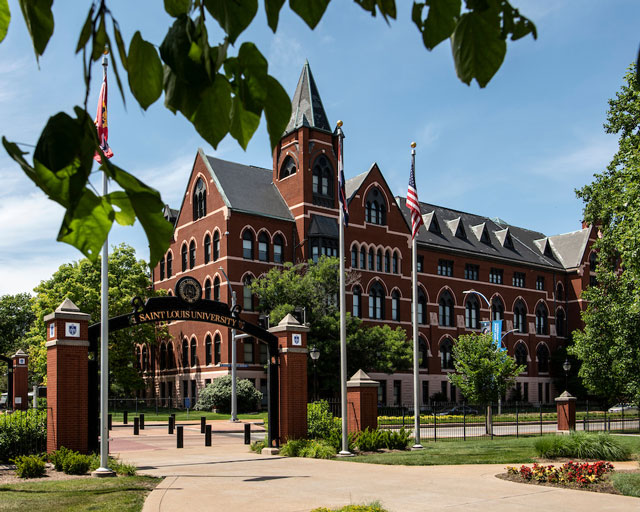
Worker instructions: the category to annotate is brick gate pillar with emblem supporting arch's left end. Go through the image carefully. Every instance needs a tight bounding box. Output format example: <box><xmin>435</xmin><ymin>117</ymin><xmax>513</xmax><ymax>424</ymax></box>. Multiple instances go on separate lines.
<box><xmin>44</xmin><ymin>299</ymin><xmax>90</xmax><ymax>453</ymax></box>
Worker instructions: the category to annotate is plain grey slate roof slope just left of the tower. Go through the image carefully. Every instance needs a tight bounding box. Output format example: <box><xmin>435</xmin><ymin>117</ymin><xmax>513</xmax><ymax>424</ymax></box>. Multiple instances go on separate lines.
<box><xmin>203</xmin><ymin>154</ymin><xmax>293</xmax><ymax>221</ymax></box>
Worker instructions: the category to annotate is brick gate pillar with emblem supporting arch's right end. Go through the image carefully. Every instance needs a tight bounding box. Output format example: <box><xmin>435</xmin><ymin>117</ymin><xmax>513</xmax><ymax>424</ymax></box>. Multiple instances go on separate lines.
<box><xmin>269</xmin><ymin>315</ymin><xmax>309</xmax><ymax>443</ymax></box>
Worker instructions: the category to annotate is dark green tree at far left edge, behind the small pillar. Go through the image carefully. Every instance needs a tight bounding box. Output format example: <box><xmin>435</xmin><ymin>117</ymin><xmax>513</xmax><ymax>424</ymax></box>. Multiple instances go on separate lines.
<box><xmin>0</xmin><ymin>293</ymin><xmax>35</xmax><ymax>356</ymax></box>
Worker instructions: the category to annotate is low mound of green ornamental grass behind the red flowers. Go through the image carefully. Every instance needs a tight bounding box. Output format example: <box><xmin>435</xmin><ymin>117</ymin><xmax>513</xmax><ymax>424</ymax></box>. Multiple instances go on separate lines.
<box><xmin>534</xmin><ymin>432</ymin><xmax>630</xmax><ymax>460</ymax></box>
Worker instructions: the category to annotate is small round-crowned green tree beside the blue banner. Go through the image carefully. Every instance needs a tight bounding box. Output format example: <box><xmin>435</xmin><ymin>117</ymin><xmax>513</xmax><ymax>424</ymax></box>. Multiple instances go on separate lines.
<box><xmin>448</xmin><ymin>333</ymin><xmax>524</xmax><ymax>404</ymax></box>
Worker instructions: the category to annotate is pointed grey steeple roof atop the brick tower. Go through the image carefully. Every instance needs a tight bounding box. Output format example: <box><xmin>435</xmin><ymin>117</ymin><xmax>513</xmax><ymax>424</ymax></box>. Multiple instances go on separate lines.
<box><xmin>285</xmin><ymin>61</ymin><xmax>332</xmax><ymax>133</ymax></box>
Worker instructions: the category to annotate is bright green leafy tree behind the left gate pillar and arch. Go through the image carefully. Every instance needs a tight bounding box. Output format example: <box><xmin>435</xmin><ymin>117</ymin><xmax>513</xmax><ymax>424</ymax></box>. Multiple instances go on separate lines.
<box><xmin>27</xmin><ymin>244</ymin><xmax>164</xmax><ymax>394</ymax></box>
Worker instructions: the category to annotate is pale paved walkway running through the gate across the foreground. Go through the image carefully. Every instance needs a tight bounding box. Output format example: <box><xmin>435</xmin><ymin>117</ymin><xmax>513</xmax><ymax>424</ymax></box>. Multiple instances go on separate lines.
<box><xmin>107</xmin><ymin>422</ymin><xmax>640</xmax><ymax>512</ymax></box>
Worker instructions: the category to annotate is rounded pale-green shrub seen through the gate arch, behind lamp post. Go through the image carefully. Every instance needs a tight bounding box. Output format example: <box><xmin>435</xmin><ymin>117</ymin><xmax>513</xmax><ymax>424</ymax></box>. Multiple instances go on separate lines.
<box><xmin>194</xmin><ymin>375</ymin><xmax>262</xmax><ymax>413</ymax></box>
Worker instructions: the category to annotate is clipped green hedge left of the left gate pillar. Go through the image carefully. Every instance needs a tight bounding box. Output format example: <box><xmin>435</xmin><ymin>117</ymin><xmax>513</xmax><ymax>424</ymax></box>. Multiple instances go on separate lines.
<box><xmin>0</xmin><ymin>410</ymin><xmax>47</xmax><ymax>463</ymax></box>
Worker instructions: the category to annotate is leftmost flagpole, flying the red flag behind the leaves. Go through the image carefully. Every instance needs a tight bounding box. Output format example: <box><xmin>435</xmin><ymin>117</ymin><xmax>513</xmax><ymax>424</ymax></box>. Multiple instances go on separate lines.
<box><xmin>94</xmin><ymin>48</ymin><xmax>115</xmax><ymax>476</ymax></box>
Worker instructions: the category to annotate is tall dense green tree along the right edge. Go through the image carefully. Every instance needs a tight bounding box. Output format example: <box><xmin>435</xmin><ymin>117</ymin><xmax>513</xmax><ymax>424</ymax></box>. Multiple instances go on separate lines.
<box><xmin>569</xmin><ymin>66</ymin><xmax>640</xmax><ymax>405</ymax></box>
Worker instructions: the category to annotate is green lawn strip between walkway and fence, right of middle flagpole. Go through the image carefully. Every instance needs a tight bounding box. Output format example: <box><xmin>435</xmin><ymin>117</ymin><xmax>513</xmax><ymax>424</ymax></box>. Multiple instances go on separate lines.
<box><xmin>342</xmin><ymin>436</ymin><xmax>640</xmax><ymax>466</ymax></box>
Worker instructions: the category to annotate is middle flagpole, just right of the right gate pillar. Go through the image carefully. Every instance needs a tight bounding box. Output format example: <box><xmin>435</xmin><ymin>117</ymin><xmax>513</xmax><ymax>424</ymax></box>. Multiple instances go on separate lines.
<box><xmin>337</xmin><ymin>121</ymin><xmax>353</xmax><ymax>457</ymax></box>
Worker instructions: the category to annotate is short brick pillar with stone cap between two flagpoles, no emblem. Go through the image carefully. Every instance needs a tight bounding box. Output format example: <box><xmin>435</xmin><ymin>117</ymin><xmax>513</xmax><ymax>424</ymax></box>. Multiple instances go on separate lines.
<box><xmin>347</xmin><ymin>370</ymin><xmax>380</xmax><ymax>432</ymax></box>
